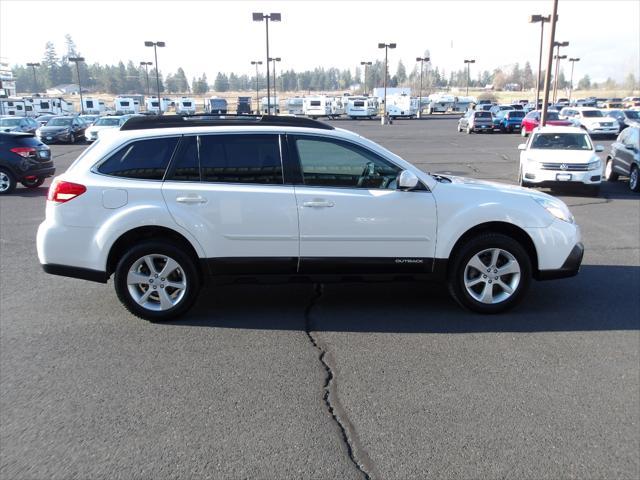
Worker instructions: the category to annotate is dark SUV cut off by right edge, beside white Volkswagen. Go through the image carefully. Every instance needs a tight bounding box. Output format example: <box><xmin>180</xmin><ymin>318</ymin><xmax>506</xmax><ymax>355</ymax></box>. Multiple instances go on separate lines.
<box><xmin>604</xmin><ymin>127</ymin><xmax>640</xmax><ymax>192</ymax></box>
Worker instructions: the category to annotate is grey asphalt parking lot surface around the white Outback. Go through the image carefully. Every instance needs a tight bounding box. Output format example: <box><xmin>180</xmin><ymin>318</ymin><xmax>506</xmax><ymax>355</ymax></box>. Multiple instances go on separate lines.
<box><xmin>0</xmin><ymin>115</ymin><xmax>640</xmax><ymax>479</ymax></box>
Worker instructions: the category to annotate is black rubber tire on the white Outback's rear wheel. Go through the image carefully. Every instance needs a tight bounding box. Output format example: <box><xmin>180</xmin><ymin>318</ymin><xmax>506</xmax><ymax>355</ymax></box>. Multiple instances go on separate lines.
<box><xmin>114</xmin><ymin>240</ymin><xmax>200</xmax><ymax>322</ymax></box>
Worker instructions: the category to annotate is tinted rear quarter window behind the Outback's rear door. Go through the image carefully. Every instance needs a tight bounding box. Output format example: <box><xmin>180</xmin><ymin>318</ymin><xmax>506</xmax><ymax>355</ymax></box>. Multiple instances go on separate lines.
<box><xmin>98</xmin><ymin>137</ymin><xmax>178</xmax><ymax>180</ymax></box>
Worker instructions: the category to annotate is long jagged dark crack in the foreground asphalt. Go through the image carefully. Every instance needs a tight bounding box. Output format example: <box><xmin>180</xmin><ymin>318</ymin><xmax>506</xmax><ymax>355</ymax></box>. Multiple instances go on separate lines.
<box><xmin>304</xmin><ymin>284</ymin><xmax>377</xmax><ymax>480</ymax></box>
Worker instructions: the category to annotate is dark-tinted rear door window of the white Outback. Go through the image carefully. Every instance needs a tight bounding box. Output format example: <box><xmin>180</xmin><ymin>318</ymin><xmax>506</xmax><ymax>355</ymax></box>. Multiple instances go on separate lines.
<box><xmin>200</xmin><ymin>135</ymin><xmax>284</xmax><ymax>185</ymax></box>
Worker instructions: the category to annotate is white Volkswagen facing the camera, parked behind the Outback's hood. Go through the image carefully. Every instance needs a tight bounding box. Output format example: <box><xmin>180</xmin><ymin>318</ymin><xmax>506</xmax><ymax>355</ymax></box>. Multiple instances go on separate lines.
<box><xmin>518</xmin><ymin>127</ymin><xmax>604</xmax><ymax>196</ymax></box>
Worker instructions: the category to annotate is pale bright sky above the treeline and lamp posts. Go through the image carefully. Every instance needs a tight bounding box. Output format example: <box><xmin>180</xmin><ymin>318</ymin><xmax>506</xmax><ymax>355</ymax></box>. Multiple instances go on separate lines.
<box><xmin>0</xmin><ymin>0</ymin><xmax>640</xmax><ymax>81</ymax></box>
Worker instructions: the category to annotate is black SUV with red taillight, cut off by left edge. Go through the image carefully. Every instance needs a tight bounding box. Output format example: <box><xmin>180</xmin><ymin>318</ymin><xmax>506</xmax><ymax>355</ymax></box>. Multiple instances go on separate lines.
<box><xmin>0</xmin><ymin>132</ymin><xmax>56</xmax><ymax>195</ymax></box>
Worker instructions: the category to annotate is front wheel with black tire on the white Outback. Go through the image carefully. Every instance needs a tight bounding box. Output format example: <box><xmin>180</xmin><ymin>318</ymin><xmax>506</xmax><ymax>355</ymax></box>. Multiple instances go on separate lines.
<box><xmin>447</xmin><ymin>233</ymin><xmax>531</xmax><ymax>314</ymax></box>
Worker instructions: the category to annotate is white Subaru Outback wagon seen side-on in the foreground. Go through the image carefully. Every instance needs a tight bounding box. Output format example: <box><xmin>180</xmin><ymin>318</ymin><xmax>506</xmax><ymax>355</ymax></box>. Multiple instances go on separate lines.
<box><xmin>37</xmin><ymin>116</ymin><xmax>583</xmax><ymax>320</ymax></box>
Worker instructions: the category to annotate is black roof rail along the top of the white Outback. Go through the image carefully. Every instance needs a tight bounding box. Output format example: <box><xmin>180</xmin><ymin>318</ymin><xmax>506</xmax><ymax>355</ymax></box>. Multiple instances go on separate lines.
<box><xmin>120</xmin><ymin>114</ymin><xmax>334</xmax><ymax>130</ymax></box>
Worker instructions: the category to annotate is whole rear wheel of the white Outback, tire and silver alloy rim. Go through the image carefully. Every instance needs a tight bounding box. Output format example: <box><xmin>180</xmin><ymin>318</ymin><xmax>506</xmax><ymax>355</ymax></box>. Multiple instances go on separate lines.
<box><xmin>115</xmin><ymin>241</ymin><xmax>200</xmax><ymax>321</ymax></box>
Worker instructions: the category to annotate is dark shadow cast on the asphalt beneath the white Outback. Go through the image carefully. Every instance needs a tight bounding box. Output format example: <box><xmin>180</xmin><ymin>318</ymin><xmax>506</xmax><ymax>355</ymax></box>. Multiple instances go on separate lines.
<box><xmin>170</xmin><ymin>265</ymin><xmax>640</xmax><ymax>333</ymax></box>
